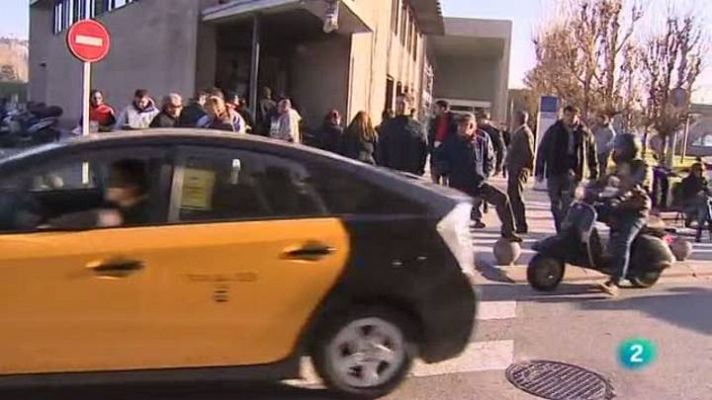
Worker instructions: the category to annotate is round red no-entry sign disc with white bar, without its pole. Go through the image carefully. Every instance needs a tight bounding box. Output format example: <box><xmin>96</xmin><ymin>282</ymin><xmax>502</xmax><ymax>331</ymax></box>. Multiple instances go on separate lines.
<box><xmin>67</xmin><ymin>19</ymin><xmax>111</xmax><ymax>62</ymax></box>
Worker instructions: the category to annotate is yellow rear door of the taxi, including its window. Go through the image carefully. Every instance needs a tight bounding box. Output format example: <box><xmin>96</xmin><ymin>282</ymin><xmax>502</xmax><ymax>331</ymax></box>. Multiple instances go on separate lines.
<box><xmin>134</xmin><ymin>147</ymin><xmax>349</xmax><ymax>367</ymax></box>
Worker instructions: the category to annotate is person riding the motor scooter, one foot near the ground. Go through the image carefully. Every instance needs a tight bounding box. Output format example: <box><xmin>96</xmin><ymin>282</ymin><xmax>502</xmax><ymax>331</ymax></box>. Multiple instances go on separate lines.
<box><xmin>600</xmin><ymin>134</ymin><xmax>651</xmax><ymax>296</ymax></box>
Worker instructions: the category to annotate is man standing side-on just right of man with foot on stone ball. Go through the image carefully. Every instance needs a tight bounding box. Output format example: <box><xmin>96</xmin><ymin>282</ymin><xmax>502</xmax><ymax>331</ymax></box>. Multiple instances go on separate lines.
<box><xmin>507</xmin><ymin>111</ymin><xmax>534</xmax><ymax>234</ymax></box>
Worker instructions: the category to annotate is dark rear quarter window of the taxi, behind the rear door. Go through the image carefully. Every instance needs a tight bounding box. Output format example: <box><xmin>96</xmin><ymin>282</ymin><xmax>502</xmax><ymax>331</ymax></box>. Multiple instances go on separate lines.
<box><xmin>309</xmin><ymin>163</ymin><xmax>426</xmax><ymax>215</ymax></box>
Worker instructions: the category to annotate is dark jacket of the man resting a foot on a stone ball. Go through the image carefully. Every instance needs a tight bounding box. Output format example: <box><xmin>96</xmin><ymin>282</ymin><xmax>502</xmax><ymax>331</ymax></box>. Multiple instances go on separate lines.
<box><xmin>435</xmin><ymin>130</ymin><xmax>495</xmax><ymax>193</ymax></box>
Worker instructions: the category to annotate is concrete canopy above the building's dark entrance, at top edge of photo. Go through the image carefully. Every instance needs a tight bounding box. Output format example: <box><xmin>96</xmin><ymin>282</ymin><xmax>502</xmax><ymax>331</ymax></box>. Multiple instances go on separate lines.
<box><xmin>203</xmin><ymin>0</ymin><xmax>372</xmax><ymax>35</ymax></box>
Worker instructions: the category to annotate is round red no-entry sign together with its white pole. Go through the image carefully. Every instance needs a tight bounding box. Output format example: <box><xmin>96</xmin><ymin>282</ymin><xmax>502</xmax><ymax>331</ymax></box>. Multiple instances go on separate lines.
<box><xmin>67</xmin><ymin>19</ymin><xmax>111</xmax><ymax>184</ymax></box>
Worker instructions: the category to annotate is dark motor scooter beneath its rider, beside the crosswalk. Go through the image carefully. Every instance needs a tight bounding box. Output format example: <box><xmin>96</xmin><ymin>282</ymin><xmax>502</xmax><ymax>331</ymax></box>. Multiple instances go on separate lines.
<box><xmin>527</xmin><ymin>186</ymin><xmax>675</xmax><ymax>292</ymax></box>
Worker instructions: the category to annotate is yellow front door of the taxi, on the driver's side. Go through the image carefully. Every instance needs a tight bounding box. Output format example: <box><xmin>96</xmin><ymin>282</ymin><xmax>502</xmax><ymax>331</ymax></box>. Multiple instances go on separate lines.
<box><xmin>0</xmin><ymin>147</ymin><xmax>172</xmax><ymax>374</ymax></box>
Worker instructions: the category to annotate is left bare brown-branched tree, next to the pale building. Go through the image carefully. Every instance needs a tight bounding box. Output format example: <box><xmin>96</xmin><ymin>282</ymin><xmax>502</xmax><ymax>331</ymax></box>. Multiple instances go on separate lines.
<box><xmin>525</xmin><ymin>0</ymin><xmax>643</xmax><ymax>119</ymax></box>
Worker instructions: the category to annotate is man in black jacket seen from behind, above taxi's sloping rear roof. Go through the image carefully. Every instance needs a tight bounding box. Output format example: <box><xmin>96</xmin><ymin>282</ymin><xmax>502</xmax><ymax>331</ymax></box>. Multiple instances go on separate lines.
<box><xmin>379</xmin><ymin>97</ymin><xmax>428</xmax><ymax>176</ymax></box>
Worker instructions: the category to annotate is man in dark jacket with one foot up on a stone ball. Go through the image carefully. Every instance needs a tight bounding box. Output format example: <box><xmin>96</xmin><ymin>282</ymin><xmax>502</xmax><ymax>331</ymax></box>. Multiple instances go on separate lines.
<box><xmin>437</xmin><ymin>114</ymin><xmax>522</xmax><ymax>242</ymax></box>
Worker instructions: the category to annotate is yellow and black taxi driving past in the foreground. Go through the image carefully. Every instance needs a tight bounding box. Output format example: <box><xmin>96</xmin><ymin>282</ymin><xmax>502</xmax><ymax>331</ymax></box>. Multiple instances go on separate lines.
<box><xmin>0</xmin><ymin>130</ymin><xmax>476</xmax><ymax>398</ymax></box>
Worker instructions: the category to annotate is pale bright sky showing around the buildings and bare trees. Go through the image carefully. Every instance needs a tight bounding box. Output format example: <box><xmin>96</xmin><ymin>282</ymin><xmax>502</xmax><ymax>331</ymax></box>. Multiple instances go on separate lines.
<box><xmin>0</xmin><ymin>0</ymin><xmax>712</xmax><ymax>99</ymax></box>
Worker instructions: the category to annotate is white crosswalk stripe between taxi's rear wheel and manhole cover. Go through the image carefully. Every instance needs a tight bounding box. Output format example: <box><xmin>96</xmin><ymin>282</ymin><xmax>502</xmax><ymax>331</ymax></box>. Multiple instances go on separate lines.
<box><xmin>412</xmin><ymin>340</ymin><xmax>514</xmax><ymax>377</ymax></box>
